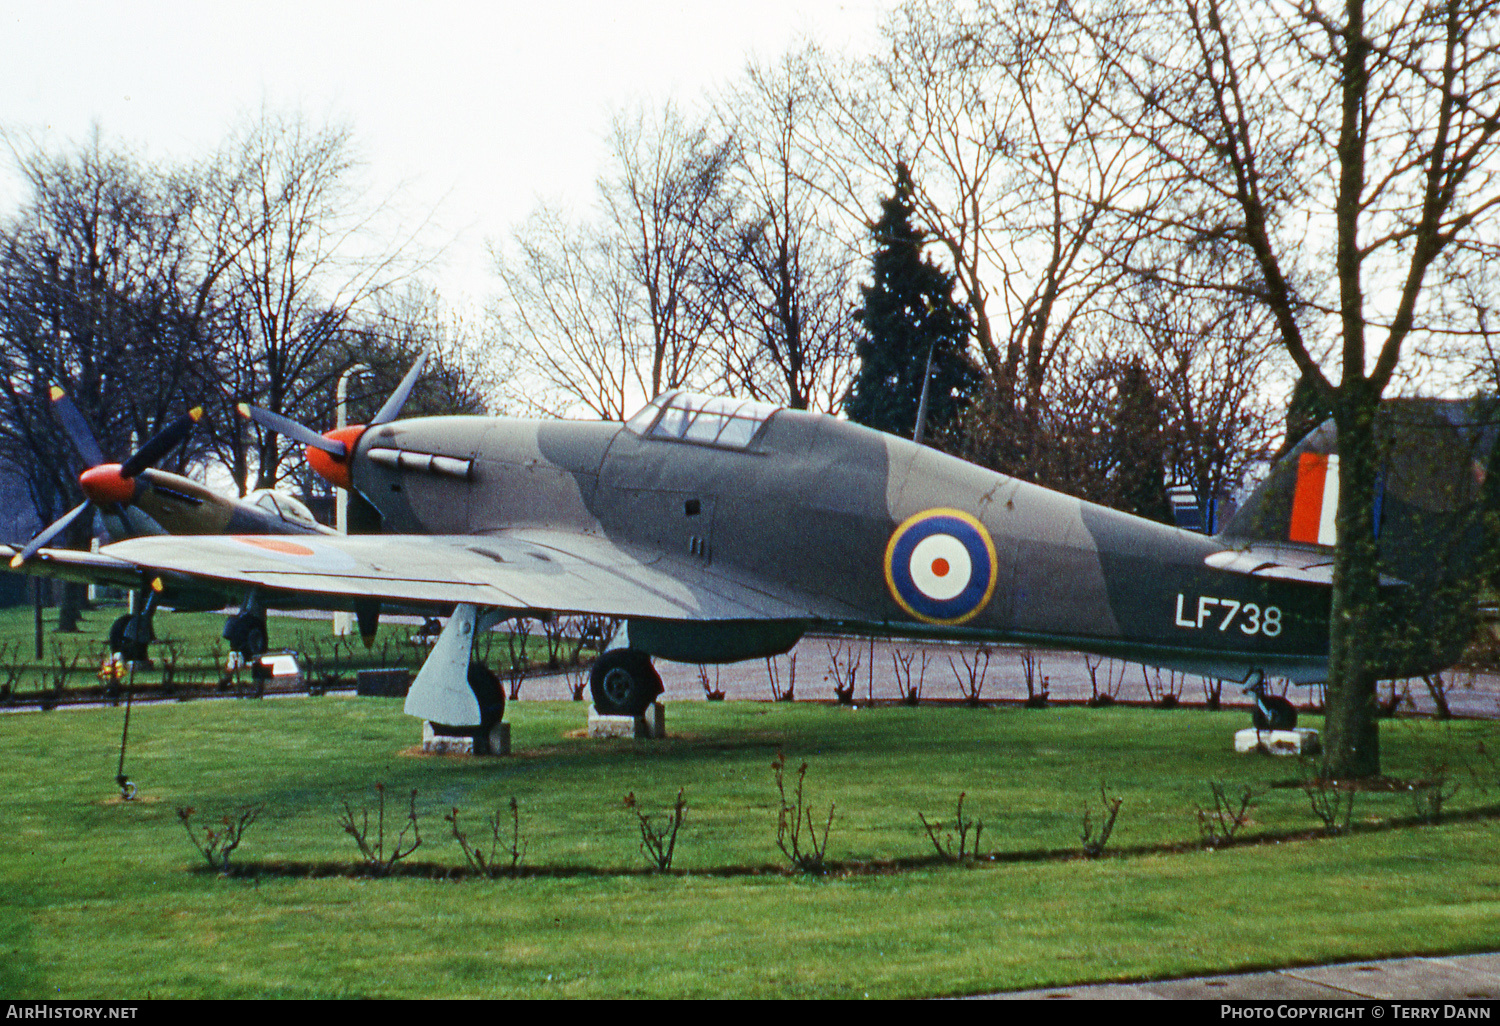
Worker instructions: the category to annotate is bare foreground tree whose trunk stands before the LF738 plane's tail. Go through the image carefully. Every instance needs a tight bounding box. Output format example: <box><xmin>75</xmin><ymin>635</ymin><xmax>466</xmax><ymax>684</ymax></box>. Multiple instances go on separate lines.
<box><xmin>1076</xmin><ymin>0</ymin><xmax>1500</xmax><ymax>777</ymax></box>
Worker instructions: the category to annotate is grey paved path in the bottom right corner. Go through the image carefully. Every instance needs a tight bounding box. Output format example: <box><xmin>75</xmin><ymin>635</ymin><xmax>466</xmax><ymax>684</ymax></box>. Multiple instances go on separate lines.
<box><xmin>981</xmin><ymin>954</ymin><xmax>1500</xmax><ymax>1001</ymax></box>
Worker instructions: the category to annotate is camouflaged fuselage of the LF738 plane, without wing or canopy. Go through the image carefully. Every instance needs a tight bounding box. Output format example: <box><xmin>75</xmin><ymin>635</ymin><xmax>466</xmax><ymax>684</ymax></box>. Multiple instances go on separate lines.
<box><xmin>353</xmin><ymin>410</ymin><xmax>1350</xmax><ymax>681</ymax></box>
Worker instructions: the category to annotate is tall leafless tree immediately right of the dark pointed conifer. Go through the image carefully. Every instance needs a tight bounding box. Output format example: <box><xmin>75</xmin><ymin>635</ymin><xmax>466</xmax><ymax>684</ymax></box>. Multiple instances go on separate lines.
<box><xmin>824</xmin><ymin>0</ymin><xmax>1155</xmax><ymax>465</ymax></box>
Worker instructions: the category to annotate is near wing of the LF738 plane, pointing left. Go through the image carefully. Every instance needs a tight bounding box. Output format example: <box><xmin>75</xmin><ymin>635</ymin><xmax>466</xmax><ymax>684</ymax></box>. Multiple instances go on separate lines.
<box><xmin>0</xmin><ymin>530</ymin><xmax>855</xmax><ymax>621</ymax></box>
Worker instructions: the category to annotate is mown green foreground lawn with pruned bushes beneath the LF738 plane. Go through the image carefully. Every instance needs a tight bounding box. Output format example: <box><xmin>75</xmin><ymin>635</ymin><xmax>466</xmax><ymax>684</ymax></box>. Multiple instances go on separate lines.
<box><xmin>0</xmin><ymin>696</ymin><xmax>1500</xmax><ymax>998</ymax></box>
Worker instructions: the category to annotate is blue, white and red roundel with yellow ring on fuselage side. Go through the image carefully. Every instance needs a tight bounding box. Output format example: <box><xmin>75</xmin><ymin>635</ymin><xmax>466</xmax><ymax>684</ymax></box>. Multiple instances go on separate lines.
<box><xmin>885</xmin><ymin>510</ymin><xmax>996</xmax><ymax>624</ymax></box>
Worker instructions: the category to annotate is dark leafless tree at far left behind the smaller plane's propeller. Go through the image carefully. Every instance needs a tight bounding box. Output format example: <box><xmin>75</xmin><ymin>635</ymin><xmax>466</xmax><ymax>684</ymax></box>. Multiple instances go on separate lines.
<box><xmin>0</xmin><ymin>134</ymin><xmax>228</xmax><ymax>629</ymax></box>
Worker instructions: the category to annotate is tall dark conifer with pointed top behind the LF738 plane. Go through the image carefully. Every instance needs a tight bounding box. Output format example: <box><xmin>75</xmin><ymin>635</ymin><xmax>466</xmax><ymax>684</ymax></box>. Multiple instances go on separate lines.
<box><xmin>845</xmin><ymin>165</ymin><xmax>981</xmax><ymax>438</ymax></box>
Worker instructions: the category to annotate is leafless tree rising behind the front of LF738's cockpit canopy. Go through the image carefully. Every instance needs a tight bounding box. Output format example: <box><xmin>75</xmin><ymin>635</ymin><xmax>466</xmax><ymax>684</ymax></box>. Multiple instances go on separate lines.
<box><xmin>492</xmin><ymin>107</ymin><xmax>734</xmax><ymax>420</ymax></box>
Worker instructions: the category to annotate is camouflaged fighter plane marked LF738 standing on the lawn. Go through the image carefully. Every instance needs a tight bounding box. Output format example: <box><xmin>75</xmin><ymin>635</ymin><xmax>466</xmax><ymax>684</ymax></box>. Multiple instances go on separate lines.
<box><xmin>5</xmin><ymin>369</ymin><xmax>1500</xmax><ymax>738</ymax></box>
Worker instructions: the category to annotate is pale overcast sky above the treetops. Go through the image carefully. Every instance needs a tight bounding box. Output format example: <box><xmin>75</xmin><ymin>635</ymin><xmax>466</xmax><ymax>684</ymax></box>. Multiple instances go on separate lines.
<box><xmin>0</xmin><ymin>0</ymin><xmax>893</xmax><ymax>303</ymax></box>
